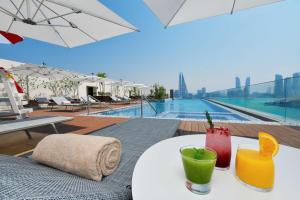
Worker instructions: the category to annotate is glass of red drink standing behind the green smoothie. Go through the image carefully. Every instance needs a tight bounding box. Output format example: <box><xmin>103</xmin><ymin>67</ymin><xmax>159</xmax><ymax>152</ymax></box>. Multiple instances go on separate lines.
<box><xmin>205</xmin><ymin>127</ymin><xmax>231</xmax><ymax>168</ymax></box>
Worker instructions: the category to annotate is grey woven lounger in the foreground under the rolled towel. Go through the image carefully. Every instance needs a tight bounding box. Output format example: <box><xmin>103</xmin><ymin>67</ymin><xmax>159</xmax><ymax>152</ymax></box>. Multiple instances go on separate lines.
<box><xmin>0</xmin><ymin>119</ymin><xmax>179</xmax><ymax>200</ymax></box>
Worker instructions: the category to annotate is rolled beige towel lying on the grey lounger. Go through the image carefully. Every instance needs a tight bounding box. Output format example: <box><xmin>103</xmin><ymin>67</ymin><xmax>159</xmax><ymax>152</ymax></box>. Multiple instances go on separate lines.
<box><xmin>32</xmin><ymin>134</ymin><xmax>121</xmax><ymax>181</ymax></box>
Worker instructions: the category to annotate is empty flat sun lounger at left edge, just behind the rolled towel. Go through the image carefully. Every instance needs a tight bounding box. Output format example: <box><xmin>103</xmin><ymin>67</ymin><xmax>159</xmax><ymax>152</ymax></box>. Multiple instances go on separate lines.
<box><xmin>0</xmin><ymin>116</ymin><xmax>73</xmax><ymax>139</ymax></box>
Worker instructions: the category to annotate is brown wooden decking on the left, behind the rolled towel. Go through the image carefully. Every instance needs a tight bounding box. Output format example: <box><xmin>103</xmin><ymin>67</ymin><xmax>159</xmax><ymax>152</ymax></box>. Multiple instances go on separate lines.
<box><xmin>0</xmin><ymin>105</ymin><xmax>132</xmax><ymax>155</ymax></box>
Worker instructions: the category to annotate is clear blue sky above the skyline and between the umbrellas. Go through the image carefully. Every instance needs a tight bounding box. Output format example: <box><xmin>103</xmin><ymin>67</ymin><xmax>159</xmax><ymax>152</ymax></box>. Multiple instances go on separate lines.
<box><xmin>0</xmin><ymin>0</ymin><xmax>300</xmax><ymax>92</ymax></box>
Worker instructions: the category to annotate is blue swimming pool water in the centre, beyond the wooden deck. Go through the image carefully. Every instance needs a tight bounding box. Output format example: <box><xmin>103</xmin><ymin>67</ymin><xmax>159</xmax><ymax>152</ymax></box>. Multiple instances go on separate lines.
<box><xmin>91</xmin><ymin>99</ymin><xmax>249</xmax><ymax>121</ymax></box>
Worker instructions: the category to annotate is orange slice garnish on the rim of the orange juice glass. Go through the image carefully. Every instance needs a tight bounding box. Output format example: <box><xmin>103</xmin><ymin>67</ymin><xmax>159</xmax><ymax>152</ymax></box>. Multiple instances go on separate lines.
<box><xmin>258</xmin><ymin>132</ymin><xmax>279</xmax><ymax>157</ymax></box>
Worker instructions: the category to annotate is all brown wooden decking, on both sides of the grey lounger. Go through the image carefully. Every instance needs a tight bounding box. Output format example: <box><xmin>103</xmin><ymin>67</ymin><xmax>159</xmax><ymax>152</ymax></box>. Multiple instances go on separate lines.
<box><xmin>0</xmin><ymin>105</ymin><xmax>300</xmax><ymax>155</ymax></box>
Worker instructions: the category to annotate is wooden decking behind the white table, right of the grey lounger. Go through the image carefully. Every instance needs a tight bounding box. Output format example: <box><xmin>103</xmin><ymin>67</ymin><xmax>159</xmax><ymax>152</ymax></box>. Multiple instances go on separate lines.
<box><xmin>178</xmin><ymin>121</ymin><xmax>300</xmax><ymax>148</ymax></box>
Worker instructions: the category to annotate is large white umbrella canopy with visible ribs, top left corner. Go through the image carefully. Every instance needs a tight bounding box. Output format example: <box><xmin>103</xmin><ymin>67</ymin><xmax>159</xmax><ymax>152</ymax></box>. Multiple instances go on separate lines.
<box><xmin>0</xmin><ymin>0</ymin><xmax>137</xmax><ymax>47</ymax></box>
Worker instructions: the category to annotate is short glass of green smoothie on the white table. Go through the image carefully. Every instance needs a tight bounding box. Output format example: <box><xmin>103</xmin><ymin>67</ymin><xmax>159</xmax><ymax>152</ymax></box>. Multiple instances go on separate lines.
<box><xmin>180</xmin><ymin>146</ymin><xmax>217</xmax><ymax>194</ymax></box>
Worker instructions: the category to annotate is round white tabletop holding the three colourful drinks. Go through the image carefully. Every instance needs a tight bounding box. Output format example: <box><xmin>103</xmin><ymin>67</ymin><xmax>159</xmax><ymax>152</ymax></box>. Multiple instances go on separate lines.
<box><xmin>132</xmin><ymin>135</ymin><xmax>300</xmax><ymax>200</ymax></box>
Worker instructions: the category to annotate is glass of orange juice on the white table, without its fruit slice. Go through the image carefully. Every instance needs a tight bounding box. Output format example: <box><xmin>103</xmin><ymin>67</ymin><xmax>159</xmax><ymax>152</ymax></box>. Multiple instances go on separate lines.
<box><xmin>235</xmin><ymin>145</ymin><xmax>275</xmax><ymax>192</ymax></box>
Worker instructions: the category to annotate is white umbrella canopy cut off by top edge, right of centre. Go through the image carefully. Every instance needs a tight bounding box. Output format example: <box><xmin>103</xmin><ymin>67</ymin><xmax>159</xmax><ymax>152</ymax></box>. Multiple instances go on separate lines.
<box><xmin>144</xmin><ymin>0</ymin><xmax>282</xmax><ymax>27</ymax></box>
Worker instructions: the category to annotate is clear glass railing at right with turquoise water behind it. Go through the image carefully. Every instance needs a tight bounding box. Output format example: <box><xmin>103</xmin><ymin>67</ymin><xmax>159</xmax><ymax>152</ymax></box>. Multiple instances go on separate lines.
<box><xmin>207</xmin><ymin>76</ymin><xmax>300</xmax><ymax>124</ymax></box>
